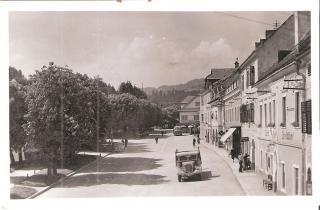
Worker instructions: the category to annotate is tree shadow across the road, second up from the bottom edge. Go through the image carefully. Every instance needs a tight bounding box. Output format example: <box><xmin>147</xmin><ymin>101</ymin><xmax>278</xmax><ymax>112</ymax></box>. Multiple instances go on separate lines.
<box><xmin>81</xmin><ymin>157</ymin><xmax>162</xmax><ymax>173</ymax></box>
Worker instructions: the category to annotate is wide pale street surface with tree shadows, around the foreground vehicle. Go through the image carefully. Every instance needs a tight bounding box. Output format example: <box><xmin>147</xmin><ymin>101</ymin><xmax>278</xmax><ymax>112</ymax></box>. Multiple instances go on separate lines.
<box><xmin>37</xmin><ymin>135</ymin><xmax>244</xmax><ymax>198</ymax></box>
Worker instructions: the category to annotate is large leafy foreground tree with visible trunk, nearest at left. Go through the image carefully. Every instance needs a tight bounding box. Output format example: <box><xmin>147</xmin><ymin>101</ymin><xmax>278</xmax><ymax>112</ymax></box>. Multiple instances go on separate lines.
<box><xmin>24</xmin><ymin>63</ymin><xmax>108</xmax><ymax>175</ymax></box>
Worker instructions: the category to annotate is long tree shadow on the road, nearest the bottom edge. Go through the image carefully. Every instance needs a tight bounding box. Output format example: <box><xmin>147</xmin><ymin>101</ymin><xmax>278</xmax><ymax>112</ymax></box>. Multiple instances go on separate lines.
<box><xmin>57</xmin><ymin>173</ymin><xmax>168</xmax><ymax>188</ymax></box>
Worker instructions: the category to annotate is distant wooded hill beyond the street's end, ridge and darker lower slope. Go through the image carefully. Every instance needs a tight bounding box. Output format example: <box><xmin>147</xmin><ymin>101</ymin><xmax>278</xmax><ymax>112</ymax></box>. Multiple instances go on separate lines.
<box><xmin>143</xmin><ymin>79</ymin><xmax>204</xmax><ymax>107</ymax></box>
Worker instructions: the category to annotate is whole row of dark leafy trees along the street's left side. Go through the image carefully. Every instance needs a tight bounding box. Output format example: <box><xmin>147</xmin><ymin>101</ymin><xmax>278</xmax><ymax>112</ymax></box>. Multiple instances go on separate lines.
<box><xmin>9</xmin><ymin>62</ymin><xmax>165</xmax><ymax>175</ymax></box>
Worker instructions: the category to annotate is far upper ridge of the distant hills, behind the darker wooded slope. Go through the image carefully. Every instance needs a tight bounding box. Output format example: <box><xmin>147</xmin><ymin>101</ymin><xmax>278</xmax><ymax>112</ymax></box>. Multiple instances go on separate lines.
<box><xmin>143</xmin><ymin>79</ymin><xmax>204</xmax><ymax>95</ymax></box>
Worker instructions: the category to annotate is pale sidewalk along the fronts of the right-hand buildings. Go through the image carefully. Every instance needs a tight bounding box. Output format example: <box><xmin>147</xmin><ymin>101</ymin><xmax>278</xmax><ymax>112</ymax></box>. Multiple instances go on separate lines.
<box><xmin>201</xmin><ymin>142</ymin><xmax>281</xmax><ymax>196</ymax></box>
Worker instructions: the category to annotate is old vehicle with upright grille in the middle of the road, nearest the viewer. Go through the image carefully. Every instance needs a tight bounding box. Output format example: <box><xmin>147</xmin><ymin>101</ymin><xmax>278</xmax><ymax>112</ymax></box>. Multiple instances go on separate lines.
<box><xmin>175</xmin><ymin>147</ymin><xmax>202</xmax><ymax>182</ymax></box>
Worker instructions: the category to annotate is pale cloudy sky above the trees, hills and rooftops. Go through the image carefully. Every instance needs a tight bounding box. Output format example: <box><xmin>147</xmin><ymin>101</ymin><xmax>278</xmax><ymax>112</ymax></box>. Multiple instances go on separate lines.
<box><xmin>9</xmin><ymin>12</ymin><xmax>291</xmax><ymax>87</ymax></box>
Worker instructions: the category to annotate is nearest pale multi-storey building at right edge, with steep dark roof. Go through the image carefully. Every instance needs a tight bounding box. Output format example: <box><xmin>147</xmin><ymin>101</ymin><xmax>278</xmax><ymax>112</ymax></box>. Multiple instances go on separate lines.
<box><xmin>245</xmin><ymin>12</ymin><xmax>311</xmax><ymax>195</ymax></box>
